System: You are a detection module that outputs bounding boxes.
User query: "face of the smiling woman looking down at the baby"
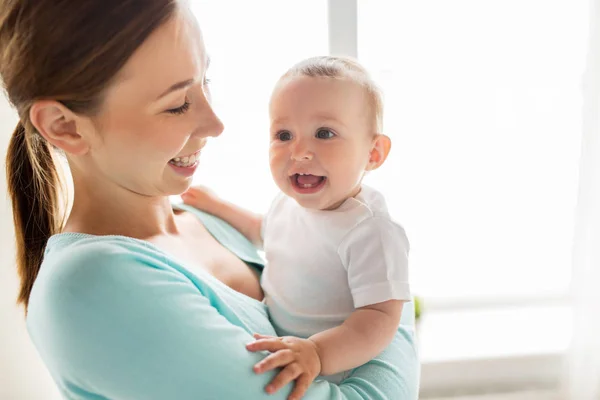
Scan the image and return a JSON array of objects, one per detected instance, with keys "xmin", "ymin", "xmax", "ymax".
[{"xmin": 76, "ymin": 10, "xmax": 223, "ymax": 196}]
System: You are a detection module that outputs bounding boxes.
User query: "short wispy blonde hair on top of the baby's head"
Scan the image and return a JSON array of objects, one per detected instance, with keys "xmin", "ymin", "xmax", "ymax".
[{"xmin": 279, "ymin": 56, "xmax": 383, "ymax": 133}]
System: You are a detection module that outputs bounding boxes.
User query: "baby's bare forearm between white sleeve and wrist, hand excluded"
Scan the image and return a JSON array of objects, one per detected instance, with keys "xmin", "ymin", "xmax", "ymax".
[{"xmin": 309, "ymin": 300, "xmax": 404, "ymax": 375}]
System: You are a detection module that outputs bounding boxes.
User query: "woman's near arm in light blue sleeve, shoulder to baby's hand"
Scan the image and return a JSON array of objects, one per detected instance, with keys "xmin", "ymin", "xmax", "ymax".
[{"xmin": 28, "ymin": 243, "xmax": 289, "ymax": 400}]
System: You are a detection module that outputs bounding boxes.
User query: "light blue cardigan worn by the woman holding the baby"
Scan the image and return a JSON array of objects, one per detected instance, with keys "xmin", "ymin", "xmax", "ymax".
[{"xmin": 27, "ymin": 206, "xmax": 419, "ymax": 400}]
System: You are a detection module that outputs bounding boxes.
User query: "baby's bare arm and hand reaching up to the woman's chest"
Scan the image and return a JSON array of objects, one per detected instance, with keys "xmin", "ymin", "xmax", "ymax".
[{"xmin": 181, "ymin": 186, "xmax": 263, "ymax": 247}]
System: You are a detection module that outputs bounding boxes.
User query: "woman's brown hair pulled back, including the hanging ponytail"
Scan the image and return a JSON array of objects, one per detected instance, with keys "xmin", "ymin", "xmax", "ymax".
[{"xmin": 0, "ymin": 0, "xmax": 177, "ymax": 309}]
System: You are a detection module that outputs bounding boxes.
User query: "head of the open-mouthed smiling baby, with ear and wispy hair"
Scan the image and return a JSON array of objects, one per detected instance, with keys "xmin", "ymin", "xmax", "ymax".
[{"xmin": 270, "ymin": 56, "xmax": 391, "ymax": 210}]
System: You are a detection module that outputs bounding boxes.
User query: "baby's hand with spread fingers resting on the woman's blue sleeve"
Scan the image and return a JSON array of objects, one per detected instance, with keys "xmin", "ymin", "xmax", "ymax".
[{"xmin": 246, "ymin": 334, "xmax": 321, "ymax": 400}]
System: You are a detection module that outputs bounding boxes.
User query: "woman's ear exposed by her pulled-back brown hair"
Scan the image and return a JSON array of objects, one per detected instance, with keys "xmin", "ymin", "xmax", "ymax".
[{"xmin": 29, "ymin": 100, "xmax": 89, "ymax": 155}]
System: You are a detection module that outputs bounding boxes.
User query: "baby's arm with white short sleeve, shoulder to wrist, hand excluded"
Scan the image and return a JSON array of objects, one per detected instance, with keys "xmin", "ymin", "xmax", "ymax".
[{"xmin": 310, "ymin": 217, "xmax": 410, "ymax": 375}]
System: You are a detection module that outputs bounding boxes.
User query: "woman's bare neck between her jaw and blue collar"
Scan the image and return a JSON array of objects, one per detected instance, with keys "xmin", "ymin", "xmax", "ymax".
[{"xmin": 64, "ymin": 173, "xmax": 178, "ymax": 239}]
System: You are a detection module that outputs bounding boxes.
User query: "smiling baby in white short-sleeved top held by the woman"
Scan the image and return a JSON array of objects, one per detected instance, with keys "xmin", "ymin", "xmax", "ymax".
[{"xmin": 182, "ymin": 57, "xmax": 411, "ymax": 399}]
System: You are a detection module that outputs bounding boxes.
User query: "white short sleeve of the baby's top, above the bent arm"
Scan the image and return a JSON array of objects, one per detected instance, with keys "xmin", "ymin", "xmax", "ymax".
[{"xmin": 338, "ymin": 217, "xmax": 411, "ymax": 308}]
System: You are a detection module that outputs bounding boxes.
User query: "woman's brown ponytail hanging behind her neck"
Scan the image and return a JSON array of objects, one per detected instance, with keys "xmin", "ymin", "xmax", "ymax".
[{"xmin": 6, "ymin": 122, "xmax": 62, "ymax": 310}]
